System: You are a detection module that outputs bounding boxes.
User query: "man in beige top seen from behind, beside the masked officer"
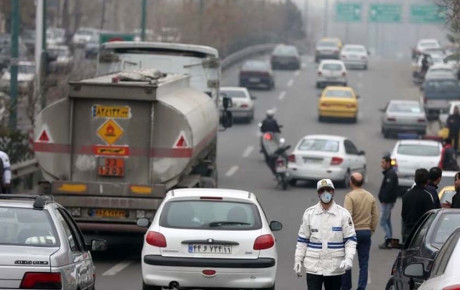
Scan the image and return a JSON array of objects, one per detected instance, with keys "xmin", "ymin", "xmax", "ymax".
[{"xmin": 342, "ymin": 173, "xmax": 379, "ymax": 290}]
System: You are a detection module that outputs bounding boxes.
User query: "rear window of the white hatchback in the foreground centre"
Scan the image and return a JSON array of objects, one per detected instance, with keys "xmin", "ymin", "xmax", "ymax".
[{"xmin": 160, "ymin": 199, "xmax": 262, "ymax": 230}]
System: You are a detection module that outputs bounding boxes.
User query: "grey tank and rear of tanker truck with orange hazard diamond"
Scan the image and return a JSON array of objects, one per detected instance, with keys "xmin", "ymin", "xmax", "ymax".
[{"xmin": 34, "ymin": 70, "xmax": 230, "ymax": 232}]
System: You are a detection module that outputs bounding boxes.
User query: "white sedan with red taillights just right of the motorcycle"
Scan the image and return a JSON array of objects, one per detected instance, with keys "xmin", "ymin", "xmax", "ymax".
[{"xmin": 288, "ymin": 135, "xmax": 366, "ymax": 186}]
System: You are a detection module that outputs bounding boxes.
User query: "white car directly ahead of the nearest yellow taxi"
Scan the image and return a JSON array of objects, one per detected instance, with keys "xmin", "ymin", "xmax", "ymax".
[{"xmin": 316, "ymin": 60, "xmax": 348, "ymax": 88}]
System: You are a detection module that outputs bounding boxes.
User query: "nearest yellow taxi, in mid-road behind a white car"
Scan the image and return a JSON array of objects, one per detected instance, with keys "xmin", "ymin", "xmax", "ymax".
[{"xmin": 318, "ymin": 86, "xmax": 359, "ymax": 123}]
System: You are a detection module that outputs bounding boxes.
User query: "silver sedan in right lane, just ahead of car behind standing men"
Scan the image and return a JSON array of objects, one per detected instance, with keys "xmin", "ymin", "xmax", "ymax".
[{"xmin": 381, "ymin": 100, "xmax": 427, "ymax": 138}]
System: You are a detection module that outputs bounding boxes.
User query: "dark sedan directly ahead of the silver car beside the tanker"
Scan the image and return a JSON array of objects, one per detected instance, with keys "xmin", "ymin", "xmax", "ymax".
[{"xmin": 240, "ymin": 60, "xmax": 275, "ymax": 90}]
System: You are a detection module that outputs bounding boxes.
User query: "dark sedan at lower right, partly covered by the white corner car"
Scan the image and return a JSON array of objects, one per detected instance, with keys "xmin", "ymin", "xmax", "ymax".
[{"xmin": 386, "ymin": 209, "xmax": 460, "ymax": 290}]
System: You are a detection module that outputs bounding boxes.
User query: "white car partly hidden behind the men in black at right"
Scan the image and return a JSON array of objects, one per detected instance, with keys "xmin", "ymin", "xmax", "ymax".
[{"xmin": 391, "ymin": 140, "xmax": 442, "ymax": 187}]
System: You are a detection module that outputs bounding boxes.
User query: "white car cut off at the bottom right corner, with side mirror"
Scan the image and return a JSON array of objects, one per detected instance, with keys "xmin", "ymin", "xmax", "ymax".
[{"xmin": 404, "ymin": 228, "xmax": 460, "ymax": 290}]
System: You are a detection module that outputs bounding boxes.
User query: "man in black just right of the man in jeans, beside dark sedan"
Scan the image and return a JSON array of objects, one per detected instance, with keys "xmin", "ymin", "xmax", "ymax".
[{"xmin": 401, "ymin": 168, "xmax": 434, "ymax": 243}]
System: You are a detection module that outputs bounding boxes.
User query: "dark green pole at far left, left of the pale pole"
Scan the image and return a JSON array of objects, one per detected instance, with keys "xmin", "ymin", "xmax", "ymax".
[{"xmin": 9, "ymin": 0, "xmax": 19, "ymax": 130}]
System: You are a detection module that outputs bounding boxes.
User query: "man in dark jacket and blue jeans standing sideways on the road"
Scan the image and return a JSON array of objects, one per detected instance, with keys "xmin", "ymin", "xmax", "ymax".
[{"xmin": 379, "ymin": 153, "xmax": 398, "ymax": 249}]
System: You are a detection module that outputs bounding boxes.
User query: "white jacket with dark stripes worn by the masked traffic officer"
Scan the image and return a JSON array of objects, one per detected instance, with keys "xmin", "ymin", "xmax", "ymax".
[{"xmin": 295, "ymin": 201, "xmax": 356, "ymax": 276}]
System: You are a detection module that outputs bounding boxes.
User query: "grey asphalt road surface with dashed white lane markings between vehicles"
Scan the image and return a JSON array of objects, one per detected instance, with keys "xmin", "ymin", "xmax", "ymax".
[{"xmin": 95, "ymin": 56, "xmax": 419, "ymax": 290}]
